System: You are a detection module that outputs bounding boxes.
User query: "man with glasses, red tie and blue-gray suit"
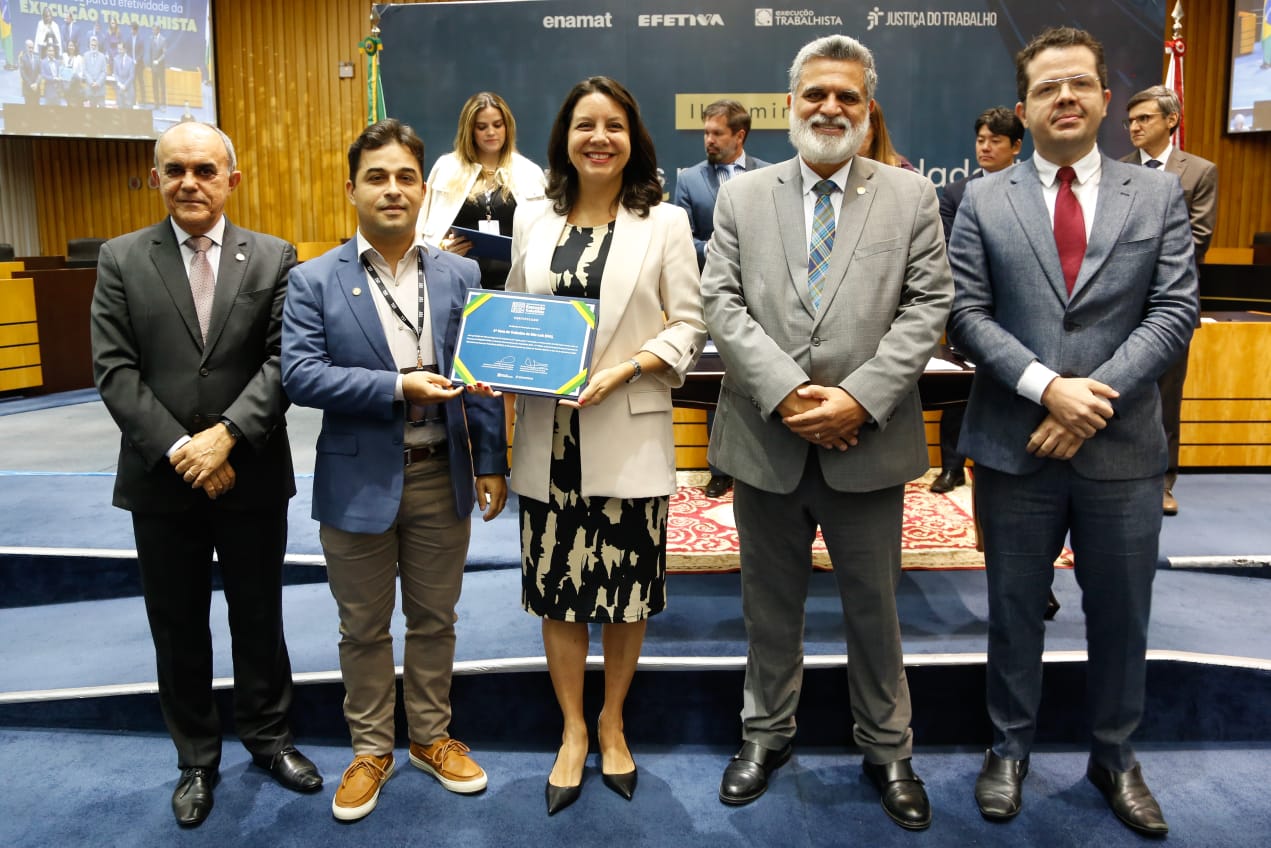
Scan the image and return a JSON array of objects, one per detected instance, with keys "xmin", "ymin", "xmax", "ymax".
[{"xmin": 949, "ymin": 27, "xmax": 1197, "ymax": 835}]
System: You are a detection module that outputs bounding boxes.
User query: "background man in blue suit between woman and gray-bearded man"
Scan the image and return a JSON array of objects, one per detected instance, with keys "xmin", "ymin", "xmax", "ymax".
[{"xmin": 671, "ymin": 100, "xmax": 768, "ymax": 497}]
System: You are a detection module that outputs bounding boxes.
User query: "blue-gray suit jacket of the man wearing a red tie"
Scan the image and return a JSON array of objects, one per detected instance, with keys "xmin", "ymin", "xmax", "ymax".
[{"xmin": 949, "ymin": 156, "xmax": 1199, "ymax": 479}]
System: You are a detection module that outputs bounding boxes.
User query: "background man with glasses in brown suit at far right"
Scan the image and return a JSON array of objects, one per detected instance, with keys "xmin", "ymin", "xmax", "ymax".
[{"xmin": 1121, "ymin": 85, "xmax": 1218, "ymax": 515}]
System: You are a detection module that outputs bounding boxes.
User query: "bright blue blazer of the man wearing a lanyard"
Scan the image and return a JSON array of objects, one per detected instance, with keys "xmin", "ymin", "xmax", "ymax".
[{"xmin": 282, "ymin": 239, "xmax": 507, "ymax": 533}]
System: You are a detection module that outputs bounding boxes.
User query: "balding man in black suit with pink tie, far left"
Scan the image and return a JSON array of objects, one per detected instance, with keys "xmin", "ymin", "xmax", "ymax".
[{"xmin": 92, "ymin": 123, "xmax": 322, "ymax": 825}]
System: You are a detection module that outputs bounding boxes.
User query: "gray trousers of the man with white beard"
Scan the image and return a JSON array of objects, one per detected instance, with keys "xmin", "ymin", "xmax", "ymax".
[{"xmin": 733, "ymin": 446, "xmax": 913, "ymax": 763}]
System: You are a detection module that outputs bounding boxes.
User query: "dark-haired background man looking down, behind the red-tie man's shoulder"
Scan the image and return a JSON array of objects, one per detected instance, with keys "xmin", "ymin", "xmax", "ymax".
[{"xmin": 932, "ymin": 106, "xmax": 1024, "ymax": 495}]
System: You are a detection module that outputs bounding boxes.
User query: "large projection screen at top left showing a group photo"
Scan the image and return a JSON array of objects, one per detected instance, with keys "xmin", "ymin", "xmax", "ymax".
[{"xmin": 0, "ymin": 0, "xmax": 216, "ymax": 139}]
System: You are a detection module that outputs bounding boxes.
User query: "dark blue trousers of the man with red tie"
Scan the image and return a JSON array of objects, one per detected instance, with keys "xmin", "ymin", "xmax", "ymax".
[{"xmin": 975, "ymin": 460, "xmax": 1160, "ymax": 772}]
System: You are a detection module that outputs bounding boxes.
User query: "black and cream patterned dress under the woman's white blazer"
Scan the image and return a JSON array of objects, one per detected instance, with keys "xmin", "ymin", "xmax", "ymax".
[{"xmin": 521, "ymin": 224, "xmax": 671, "ymax": 624}]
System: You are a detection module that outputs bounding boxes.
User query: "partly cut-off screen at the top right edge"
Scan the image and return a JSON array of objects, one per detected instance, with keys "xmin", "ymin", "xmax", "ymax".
[{"xmin": 1227, "ymin": 0, "xmax": 1271, "ymax": 132}]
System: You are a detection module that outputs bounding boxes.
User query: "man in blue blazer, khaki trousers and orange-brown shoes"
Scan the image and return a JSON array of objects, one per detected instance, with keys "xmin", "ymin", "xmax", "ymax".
[{"xmin": 282, "ymin": 120, "xmax": 507, "ymax": 821}]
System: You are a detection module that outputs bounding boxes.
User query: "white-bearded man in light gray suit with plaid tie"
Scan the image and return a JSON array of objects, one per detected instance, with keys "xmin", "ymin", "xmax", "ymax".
[{"xmin": 702, "ymin": 36, "xmax": 953, "ymax": 829}]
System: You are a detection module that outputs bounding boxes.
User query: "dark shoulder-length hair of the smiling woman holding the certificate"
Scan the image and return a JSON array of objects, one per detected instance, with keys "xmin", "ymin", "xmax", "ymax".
[{"xmin": 545, "ymin": 76, "xmax": 662, "ymax": 217}]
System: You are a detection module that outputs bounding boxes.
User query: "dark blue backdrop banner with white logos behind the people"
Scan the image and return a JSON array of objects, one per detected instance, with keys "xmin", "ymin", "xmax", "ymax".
[{"xmin": 376, "ymin": 0, "xmax": 1166, "ymax": 191}]
